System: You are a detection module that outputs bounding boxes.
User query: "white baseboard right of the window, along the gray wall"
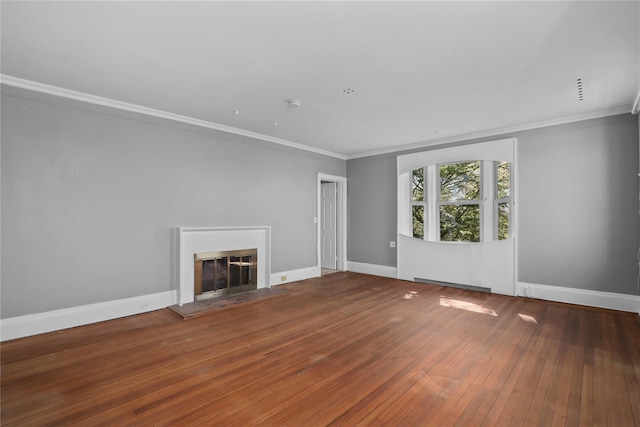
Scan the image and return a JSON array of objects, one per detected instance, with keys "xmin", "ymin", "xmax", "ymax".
[{"xmin": 516, "ymin": 282, "xmax": 640, "ymax": 314}]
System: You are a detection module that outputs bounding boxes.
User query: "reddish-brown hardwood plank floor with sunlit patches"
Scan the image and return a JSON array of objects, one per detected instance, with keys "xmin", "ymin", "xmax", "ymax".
[{"xmin": 1, "ymin": 272, "xmax": 640, "ymax": 426}]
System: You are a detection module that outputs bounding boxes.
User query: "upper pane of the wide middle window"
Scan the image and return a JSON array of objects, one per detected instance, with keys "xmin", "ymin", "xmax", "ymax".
[{"xmin": 439, "ymin": 161, "xmax": 480, "ymax": 201}]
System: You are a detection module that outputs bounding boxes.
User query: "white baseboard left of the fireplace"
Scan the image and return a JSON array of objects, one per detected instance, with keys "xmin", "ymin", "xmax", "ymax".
[{"xmin": 0, "ymin": 291, "xmax": 177, "ymax": 341}]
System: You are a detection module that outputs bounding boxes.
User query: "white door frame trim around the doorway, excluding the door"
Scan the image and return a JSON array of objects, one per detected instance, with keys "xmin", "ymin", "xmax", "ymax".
[{"xmin": 315, "ymin": 172, "xmax": 347, "ymax": 276}]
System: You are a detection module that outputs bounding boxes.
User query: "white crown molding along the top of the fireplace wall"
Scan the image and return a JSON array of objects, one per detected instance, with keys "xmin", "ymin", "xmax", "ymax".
[{"xmin": 0, "ymin": 74, "xmax": 347, "ymax": 160}]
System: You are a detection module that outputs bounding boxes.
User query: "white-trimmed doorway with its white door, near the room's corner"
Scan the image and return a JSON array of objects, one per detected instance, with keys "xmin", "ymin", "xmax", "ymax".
[{"xmin": 316, "ymin": 173, "xmax": 347, "ymax": 274}]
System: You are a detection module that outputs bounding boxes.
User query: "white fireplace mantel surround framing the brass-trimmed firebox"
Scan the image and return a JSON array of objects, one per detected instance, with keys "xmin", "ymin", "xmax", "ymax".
[{"xmin": 176, "ymin": 226, "xmax": 271, "ymax": 305}]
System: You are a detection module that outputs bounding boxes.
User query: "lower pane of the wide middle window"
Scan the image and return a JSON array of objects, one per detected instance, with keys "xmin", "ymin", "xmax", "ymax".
[{"xmin": 440, "ymin": 205, "xmax": 480, "ymax": 242}]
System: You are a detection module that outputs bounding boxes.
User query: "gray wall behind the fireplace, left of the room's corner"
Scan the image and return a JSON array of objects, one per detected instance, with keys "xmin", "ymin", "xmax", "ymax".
[{"xmin": 1, "ymin": 88, "xmax": 346, "ymax": 318}]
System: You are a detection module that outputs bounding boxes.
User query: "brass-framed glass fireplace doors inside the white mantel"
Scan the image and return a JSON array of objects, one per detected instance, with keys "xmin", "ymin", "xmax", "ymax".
[{"xmin": 193, "ymin": 248, "xmax": 258, "ymax": 300}]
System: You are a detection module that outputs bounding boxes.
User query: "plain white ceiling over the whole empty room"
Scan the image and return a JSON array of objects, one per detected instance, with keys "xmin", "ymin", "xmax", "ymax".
[{"xmin": 1, "ymin": 1, "xmax": 640, "ymax": 158}]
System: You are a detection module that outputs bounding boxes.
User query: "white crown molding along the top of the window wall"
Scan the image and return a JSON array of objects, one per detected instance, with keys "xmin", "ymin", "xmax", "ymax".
[{"xmin": 347, "ymin": 106, "xmax": 638, "ymax": 160}]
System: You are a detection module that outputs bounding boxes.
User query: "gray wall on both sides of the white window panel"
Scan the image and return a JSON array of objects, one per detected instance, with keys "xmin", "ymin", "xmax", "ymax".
[{"xmin": 347, "ymin": 114, "xmax": 639, "ymax": 294}]
